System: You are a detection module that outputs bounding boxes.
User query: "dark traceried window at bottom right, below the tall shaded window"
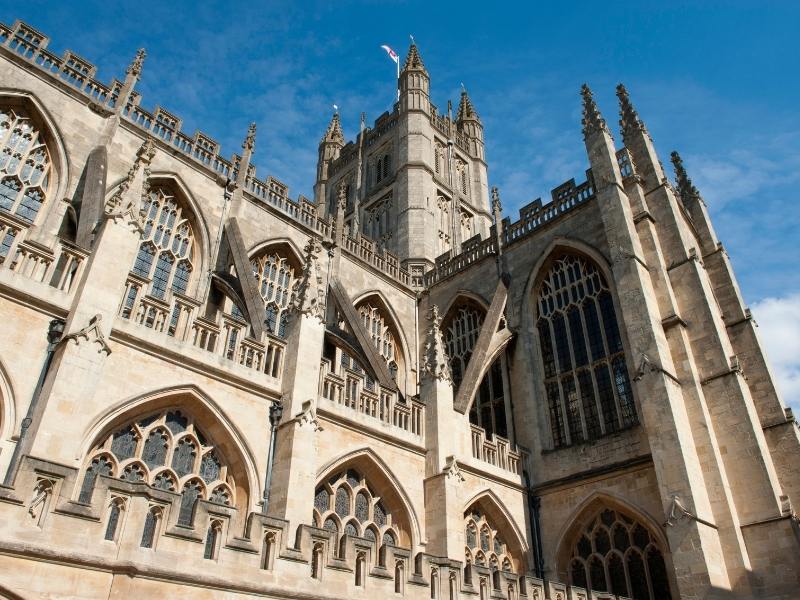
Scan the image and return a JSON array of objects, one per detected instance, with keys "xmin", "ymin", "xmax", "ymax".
[{"xmin": 569, "ymin": 509, "xmax": 672, "ymax": 600}]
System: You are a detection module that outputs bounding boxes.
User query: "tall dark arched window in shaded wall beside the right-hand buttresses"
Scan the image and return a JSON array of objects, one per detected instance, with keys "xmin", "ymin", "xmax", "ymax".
[{"xmin": 536, "ymin": 254, "xmax": 637, "ymax": 447}]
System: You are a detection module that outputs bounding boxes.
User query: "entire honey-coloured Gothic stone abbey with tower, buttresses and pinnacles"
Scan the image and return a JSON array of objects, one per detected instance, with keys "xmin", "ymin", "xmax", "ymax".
[{"xmin": 0, "ymin": 22, "xmax": 800, "ymax": 600}]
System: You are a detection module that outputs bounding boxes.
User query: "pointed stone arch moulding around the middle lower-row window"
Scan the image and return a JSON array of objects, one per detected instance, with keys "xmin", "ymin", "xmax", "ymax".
[{"xmin": 317, "ymin": 448, "xmax": 422, "ymax": 548}]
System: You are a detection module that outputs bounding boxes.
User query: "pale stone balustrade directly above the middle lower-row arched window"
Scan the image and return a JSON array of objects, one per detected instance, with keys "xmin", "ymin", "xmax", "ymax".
[{"xmin": 320, "ymin": 360, "xmax": 425, "ymax": 438}]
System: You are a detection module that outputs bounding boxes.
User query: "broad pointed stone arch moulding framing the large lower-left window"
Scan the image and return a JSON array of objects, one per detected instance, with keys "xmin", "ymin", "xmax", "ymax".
[{"xmin": 75, "ymin": 385, "xmax": 261, "ymax": 512}]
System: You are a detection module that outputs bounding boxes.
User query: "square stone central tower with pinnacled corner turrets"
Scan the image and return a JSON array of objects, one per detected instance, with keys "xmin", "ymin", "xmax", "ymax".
[{"xmin": 315, "ymin": 44, "xmax": 491, "ymax": 276}]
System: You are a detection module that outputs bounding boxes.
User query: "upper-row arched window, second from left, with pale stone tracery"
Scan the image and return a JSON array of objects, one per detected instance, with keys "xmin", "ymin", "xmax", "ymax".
[{"xmin": 132, "ymin": 186, "xmax": 196, "ymax": 300}]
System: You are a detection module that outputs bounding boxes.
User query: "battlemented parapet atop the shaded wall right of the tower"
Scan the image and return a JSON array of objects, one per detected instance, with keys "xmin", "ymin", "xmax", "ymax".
[{"xmin": 423, "ymin": 171, "xmax": 595, "ymax": 286}]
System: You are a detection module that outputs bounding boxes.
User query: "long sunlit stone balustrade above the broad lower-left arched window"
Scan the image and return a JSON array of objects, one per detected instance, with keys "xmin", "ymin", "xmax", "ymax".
[{"xmin": 119, "ymin": 273, "xmax": 286, "ymax": 380}]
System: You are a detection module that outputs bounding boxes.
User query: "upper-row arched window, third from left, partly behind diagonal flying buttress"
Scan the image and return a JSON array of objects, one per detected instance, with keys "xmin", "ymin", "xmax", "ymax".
[{"xmin": 251, "ymin": 251, "xmax": 295, "ymax": 337}]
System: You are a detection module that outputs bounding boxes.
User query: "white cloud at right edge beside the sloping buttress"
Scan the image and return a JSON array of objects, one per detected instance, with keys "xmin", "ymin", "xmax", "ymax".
[{"xmin": 752, "ymin": 293, "xmax": 800, "ymax": 416}]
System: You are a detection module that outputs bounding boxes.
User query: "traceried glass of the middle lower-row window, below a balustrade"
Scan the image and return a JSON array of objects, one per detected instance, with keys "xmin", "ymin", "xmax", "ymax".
[{"xmin": 313, "ymin": 469, "xmax": 400, "ymax": 546}]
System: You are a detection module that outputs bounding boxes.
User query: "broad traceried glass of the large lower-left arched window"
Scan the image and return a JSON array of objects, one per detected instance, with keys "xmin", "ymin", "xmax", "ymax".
[{"xmin": 79, "ymin": 409, "xmax": 236, "ymax": 524}]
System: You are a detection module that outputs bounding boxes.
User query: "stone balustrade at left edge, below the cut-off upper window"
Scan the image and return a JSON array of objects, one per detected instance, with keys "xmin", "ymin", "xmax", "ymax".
[{"xmin": 0, "ymin": 210, "xmax": 89, "ymax": 293}]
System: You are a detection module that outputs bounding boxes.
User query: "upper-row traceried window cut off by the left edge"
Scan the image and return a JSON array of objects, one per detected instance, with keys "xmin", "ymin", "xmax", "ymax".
[{"xmin": 0, "ymin": 107, "xmax": 52, "ymax": 223}]
